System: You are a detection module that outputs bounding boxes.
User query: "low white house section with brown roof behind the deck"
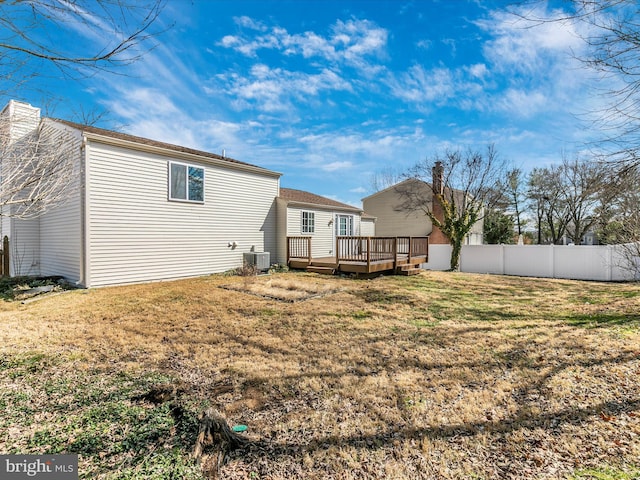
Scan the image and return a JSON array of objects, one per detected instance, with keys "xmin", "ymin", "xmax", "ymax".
[{"xmin": 276, "ymin": 188, "xmax": 375, "ymax": 263}]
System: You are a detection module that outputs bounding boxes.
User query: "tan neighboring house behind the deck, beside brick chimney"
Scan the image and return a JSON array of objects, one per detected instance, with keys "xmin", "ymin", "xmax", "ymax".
[{"xmin": 362, "ymin": 179, "xmax": 483, "ymax": 245}]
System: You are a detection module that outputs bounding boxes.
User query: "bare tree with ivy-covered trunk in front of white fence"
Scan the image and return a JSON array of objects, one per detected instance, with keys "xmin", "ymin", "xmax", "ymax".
[{"xmin": 396, "ymin": 145, "xmax": 506, "ymax": 270}]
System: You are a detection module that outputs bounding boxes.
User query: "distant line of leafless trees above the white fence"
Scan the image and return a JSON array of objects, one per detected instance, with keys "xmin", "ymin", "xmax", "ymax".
[{"xmin": 484, "ymin": 156, "xmax": 640, "ymax": 245}]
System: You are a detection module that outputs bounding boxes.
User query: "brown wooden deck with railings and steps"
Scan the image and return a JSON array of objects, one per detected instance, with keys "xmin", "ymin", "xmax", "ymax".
[{"xmin": 287, "ymin": 237, "xmax": 429, "ymax": 275}]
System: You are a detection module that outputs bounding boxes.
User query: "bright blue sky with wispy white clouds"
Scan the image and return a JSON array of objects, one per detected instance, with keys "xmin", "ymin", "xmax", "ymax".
[{"xmin": 0, "ymin": 0, "xmax": 603, "ymax": 206}]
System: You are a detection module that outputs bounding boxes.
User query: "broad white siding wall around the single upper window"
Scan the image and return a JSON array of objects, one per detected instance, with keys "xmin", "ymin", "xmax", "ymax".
[{"xmin": 86, "ymin": 142, "xmax": 278, "ymax": 286}]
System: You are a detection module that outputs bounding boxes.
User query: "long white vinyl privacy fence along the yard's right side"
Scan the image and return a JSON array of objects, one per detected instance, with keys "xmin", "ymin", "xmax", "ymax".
[{"xmin": 422, "ymin": 245, "xmax": 640, "ymax": 281}]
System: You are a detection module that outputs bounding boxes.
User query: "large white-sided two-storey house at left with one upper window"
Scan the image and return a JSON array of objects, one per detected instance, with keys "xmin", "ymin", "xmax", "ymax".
[{"xmin": 0, "ymin": 101, "xmax": 280, "ymax": 287}]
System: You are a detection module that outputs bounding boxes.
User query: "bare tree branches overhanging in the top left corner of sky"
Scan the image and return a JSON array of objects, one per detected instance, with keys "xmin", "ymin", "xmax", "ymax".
[{"xmin": 0, "ymin": 0, "xmax": 163, "ymax": 93}]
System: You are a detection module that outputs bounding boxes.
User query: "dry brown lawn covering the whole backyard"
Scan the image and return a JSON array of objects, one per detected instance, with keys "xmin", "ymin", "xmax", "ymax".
[{"xmin": 0, "ymin": 272, "xmax": 640, "ymax": 479}]
